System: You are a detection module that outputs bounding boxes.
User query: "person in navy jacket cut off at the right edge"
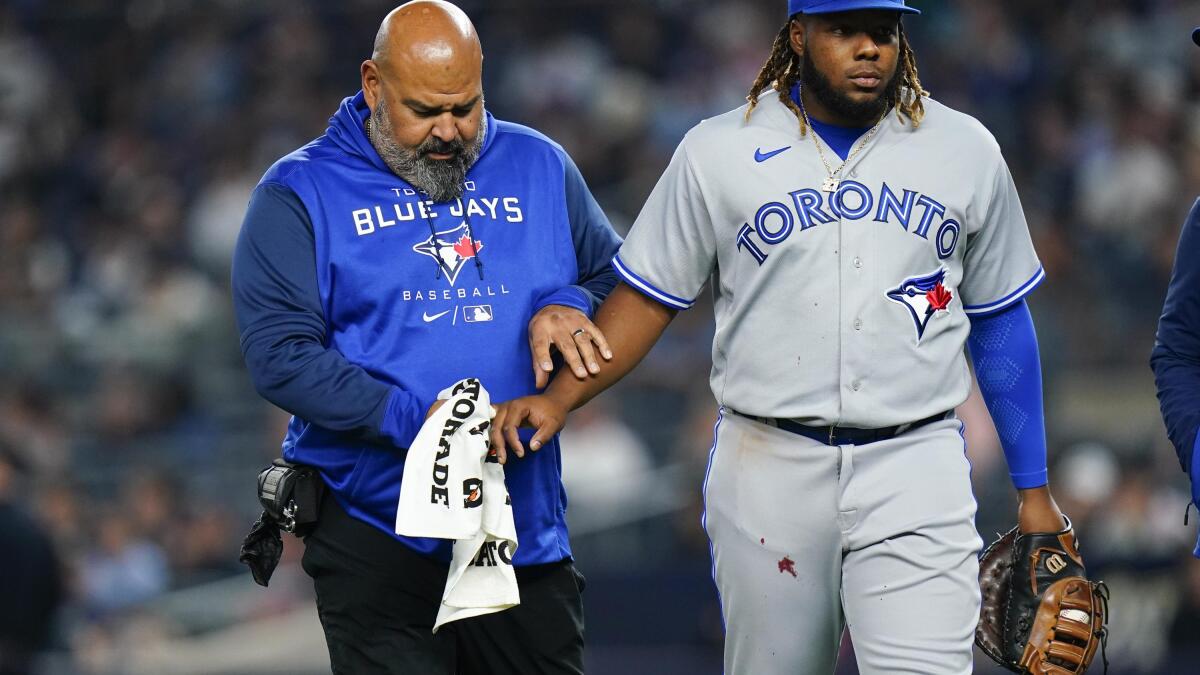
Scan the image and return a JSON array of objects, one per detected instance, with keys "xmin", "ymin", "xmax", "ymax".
[{"xmin": 1150, "ymin": 28, "xmax": 1200, "ymax": 557}]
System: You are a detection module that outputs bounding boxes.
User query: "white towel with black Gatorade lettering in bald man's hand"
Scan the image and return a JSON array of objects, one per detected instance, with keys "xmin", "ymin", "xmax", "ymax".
[{"xmin": 396, "ymin": 378, "xmax": 521, "ymax": 633}]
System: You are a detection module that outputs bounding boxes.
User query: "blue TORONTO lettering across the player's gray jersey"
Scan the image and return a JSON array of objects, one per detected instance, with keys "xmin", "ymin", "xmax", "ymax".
[{"xmin": 738, "ymin": 180, "xmax": 962, "ymax": 265}]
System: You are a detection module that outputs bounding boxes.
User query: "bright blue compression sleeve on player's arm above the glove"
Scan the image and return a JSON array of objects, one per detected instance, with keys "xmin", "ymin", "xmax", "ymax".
[{"xmin": 967, "ymin": 300, "xmax": 1048, "ymax": 490}]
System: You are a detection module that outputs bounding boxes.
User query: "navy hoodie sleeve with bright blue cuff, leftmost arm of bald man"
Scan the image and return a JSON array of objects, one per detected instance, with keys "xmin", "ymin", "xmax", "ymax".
[{"xmin": 233, "ymin": 184, "xmax": 427, "ymax": 448}]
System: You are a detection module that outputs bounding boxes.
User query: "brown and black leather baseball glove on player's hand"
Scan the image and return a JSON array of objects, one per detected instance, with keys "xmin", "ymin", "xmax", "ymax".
[{"xmin": 976, "ymin": 521, "xmax": 1109, "ymax": 675}]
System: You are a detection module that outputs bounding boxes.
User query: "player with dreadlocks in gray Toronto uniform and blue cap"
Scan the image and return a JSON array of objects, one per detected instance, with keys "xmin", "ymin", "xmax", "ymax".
[{"xmin": 492, "ymin": 0, "xmax": 1066, "ymax": 675}]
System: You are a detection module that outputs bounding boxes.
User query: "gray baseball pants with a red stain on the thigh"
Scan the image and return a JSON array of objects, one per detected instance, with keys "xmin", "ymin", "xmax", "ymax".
[{"xmin": 704, "ymin": 411, "xmax": 983, "ymax": 675}]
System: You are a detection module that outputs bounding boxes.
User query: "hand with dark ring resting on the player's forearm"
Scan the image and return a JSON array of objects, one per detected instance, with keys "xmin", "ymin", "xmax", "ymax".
[{"xmin": 529, "ymin": 305, "xmax": 612, "ymax": 389}]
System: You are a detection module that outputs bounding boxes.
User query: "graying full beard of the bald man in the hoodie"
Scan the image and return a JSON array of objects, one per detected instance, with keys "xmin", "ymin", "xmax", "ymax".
[{"xmin": 366, "ymin": 98, "xmax": 487, "ymax": 203}]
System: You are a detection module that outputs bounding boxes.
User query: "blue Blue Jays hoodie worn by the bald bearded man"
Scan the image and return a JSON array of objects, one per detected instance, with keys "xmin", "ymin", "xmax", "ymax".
[{"xmin": 233, "ymin": 91, "xmax": 620, "ymax": 566}]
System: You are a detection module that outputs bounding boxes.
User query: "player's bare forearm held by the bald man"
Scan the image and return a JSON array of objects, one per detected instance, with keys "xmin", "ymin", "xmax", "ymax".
[{"xmin": 546, "ymin": 283, "xmax": 676, "ymax": 410}]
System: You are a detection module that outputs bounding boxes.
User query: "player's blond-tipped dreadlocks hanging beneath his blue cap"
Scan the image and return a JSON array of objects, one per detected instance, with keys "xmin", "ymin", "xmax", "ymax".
[{"xmin": 746, "ymin": 19, "xmax": 929, "ymax": 136}]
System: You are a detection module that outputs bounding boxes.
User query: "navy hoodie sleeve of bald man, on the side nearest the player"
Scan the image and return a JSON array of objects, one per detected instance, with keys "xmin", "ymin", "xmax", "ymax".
[{"xmin": 533, "ymin": 153, "xmax": 620, "ymax": 318}]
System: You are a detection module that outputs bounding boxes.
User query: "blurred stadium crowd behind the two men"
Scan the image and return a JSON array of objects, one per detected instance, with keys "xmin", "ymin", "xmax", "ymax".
[{"xmin": 0, "ymin": 0, "xmax": 1200, "ymax": 675}]
